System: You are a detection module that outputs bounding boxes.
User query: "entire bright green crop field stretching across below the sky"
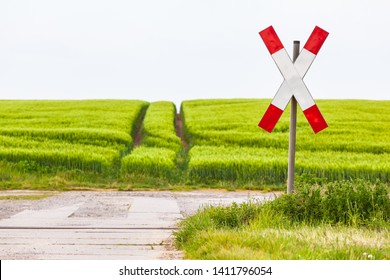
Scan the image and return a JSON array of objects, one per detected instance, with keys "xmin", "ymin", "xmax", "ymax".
[{"xmin": 0, "ymin": 99, "xmax": 390, "ymax": 189}]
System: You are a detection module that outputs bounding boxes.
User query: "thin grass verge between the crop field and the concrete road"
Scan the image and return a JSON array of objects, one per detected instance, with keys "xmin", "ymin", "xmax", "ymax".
[{"xmin": 0, "ymin": 161, "xmax": 284, "ymax": 191}]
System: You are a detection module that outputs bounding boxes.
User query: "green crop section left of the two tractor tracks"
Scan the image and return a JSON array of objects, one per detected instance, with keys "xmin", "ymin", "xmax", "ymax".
[{"xmin": 0, "ymin": 100, "xmax": 147, "ymax": 178}]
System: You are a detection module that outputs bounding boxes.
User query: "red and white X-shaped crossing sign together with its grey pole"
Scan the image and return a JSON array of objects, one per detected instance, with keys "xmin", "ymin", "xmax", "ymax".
[{"xmin": 258, "ymin": 25, "xmax": 329, "ymax": 190}]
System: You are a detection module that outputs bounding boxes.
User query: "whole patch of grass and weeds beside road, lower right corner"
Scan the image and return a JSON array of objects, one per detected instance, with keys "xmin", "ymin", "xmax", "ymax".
[{"xmin": 175, "ymin": 181, "xmax": 390, "ymax": 260}]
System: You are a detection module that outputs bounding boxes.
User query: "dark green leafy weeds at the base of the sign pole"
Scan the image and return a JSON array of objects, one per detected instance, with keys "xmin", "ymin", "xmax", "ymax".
[{"xmin": 264, "ymin": 180, "xmax": 390, "ymax": 227}]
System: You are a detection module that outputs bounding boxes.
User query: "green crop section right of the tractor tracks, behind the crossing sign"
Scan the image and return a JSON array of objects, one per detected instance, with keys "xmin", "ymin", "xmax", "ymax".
[{"xmin": 182, "ymin": 99, "xmax": 390, "ymax": 183}]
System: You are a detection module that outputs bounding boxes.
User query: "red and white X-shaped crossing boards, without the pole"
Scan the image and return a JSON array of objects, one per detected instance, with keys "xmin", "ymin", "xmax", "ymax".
[{"xmin": 259, "ymin": 26, "xmax": 329, "ymax": 133}]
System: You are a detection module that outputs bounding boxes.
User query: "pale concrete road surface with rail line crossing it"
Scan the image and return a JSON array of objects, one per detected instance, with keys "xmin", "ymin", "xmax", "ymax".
[{"xmin": 0, "ymin": 191, "xmax": 275, "ymax": 260}]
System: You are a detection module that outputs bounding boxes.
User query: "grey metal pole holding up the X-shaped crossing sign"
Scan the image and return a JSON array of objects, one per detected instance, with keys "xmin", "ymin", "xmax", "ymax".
[{"xmin": 287, "ymin": 41, "xmax": 300, "ymax": 193}]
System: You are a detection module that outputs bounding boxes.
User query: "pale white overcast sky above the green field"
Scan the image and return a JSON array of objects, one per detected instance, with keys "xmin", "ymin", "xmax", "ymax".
[{"xmin": 0, "ymin": 0, "xmax": 390, "ymax": 104}]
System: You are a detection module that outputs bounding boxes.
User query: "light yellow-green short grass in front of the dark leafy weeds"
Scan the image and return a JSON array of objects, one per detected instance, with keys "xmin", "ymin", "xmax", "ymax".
[{"xmin": 182, "ymin": 224, "xmax": 390, "ymax": 260}]
